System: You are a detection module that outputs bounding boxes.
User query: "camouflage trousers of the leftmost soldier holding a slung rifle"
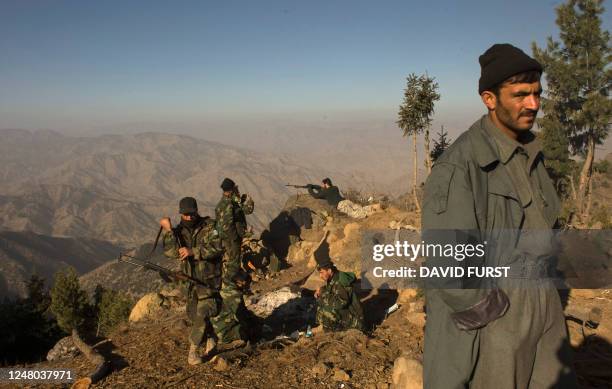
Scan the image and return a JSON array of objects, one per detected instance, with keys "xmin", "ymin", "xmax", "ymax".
[{"xmin": 187, "ymin": 292, "xmax": 221, "ymax": 346}]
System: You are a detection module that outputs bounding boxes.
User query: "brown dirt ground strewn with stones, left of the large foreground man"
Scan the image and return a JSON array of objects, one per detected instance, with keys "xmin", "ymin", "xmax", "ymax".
[{"xmin": 17, "ymin": 266, "xmax": 423, "ymax": 389}]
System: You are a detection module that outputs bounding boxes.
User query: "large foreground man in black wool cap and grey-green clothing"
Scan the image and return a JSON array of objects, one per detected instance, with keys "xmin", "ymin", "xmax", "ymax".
[{"xmin": 422, "ymin": 44, "xmax": 576, "ymax": 389}]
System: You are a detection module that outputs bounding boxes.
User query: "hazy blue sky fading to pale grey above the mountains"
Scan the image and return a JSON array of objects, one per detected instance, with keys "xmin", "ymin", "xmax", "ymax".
[{"xmin": 0, "ymin": 0, "xmax": 609, "ymax": 133}]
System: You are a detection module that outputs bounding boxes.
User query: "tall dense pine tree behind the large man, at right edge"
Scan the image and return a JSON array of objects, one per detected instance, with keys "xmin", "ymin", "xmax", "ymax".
[{"xmin": 532, "ymin": 0, "xmax": 612, "ymax": 221}]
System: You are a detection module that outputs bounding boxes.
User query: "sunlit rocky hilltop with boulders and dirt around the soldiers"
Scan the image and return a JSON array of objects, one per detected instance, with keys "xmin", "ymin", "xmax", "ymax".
[{"xmin": 21, "ymin": 202, "xmax": 612, "ymax": 389}]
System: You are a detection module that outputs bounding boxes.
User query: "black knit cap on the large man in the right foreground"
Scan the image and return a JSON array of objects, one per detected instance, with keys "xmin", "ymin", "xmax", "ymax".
[{"xmin": 478, "ymin": 43, "xmax": 542, "ymax": 94}]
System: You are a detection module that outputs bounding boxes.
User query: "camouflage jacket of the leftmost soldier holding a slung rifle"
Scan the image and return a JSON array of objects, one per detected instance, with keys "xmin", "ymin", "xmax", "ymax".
[{"xmin": 163, "ymin": 217, "xmax": 223, "ymax": 297}]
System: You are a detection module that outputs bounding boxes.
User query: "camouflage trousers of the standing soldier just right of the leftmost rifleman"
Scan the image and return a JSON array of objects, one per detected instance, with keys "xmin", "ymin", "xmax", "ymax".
[{"xmin": 211, "ymin": 258, "xmax": 244, "ymax": 343}]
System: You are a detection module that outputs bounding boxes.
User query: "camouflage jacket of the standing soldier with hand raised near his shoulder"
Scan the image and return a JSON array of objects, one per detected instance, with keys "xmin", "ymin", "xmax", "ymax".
[{"xmin": 215, "ymin": 195, "xmax": 255, "ymax": 257}]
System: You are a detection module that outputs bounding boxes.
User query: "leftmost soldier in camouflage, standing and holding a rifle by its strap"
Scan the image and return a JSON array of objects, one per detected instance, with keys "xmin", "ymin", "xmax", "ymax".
[{"xmin": 160, "ymin": 197, "xmax": 223, "ymax": 365}]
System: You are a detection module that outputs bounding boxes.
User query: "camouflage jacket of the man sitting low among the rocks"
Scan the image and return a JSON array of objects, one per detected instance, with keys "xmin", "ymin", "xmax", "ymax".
[{"xmin": 317, "ymin": 271, "xmax": 365, "ymax": 331}]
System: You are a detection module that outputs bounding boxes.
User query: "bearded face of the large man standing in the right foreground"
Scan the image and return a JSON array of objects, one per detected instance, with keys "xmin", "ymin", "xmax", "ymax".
[{"xmin": 485, "ymin": 81, "xmax": 542, "ymax": 133}]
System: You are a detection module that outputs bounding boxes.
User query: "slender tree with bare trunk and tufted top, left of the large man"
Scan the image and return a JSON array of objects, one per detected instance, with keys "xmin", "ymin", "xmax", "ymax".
[{"xmin": 396, "ymin": 73, "xmax": 440, "ymax": 212}]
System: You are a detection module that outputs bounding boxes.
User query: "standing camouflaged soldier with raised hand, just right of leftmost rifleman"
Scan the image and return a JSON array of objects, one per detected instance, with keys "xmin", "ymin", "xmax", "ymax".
[{"xmin": 212, "ymin": 178, "xmax": 254, "ymax": 343}]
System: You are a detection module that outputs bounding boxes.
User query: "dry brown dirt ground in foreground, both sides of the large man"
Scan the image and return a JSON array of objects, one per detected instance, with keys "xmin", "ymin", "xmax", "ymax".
[{"xmin": 14, "ymin": 273, "xmax": 612, "ymax": 389}]
